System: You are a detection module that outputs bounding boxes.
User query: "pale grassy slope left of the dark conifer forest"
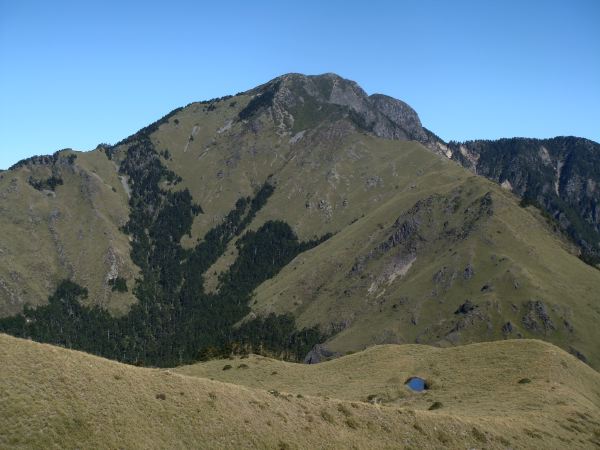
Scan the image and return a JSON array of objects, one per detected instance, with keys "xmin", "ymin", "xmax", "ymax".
[{"xmin": 0, "ymin": 151, "xmax": 137, "ymax": 315}]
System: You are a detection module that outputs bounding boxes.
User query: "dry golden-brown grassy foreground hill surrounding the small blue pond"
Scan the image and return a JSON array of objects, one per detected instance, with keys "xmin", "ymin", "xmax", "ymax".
[{"xmin": 0, "ymin": 335, "xmax": 600, "ymax": 449}]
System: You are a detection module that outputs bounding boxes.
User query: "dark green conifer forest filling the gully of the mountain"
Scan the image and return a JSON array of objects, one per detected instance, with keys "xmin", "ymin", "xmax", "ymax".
[{"xmin": 0, "ymin": 126, "xmax": 329, "ymax": 366}]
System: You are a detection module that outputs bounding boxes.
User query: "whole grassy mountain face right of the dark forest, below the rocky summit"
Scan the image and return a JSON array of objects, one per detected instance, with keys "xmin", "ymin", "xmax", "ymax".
[{"xmin": 126, "ymin": 95, "xmax": 600, "ymax": 367}]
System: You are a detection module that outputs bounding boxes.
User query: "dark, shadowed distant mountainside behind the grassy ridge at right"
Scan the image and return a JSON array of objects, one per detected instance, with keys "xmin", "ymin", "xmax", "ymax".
[{"xmin": 448, "ymin": 137, "xmax": 600, "ymax": 265}]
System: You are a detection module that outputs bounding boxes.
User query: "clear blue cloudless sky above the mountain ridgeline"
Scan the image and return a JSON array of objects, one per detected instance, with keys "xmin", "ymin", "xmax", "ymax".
[{"xmin": 0, "ymin": 0, "xmax": 600, "ymax": 168}]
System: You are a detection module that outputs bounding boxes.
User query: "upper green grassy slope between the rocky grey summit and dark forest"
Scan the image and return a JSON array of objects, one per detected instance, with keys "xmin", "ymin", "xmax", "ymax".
[{"xmin": 153, "ymin": 96, "xmax": 446, "ymax": 243}]
